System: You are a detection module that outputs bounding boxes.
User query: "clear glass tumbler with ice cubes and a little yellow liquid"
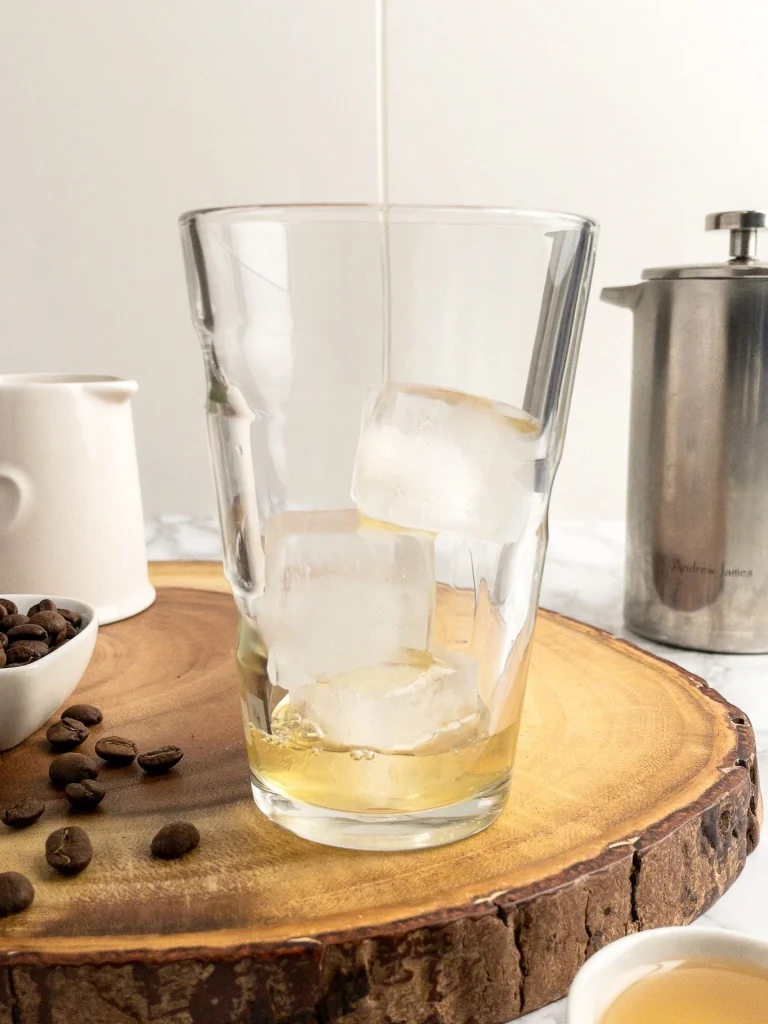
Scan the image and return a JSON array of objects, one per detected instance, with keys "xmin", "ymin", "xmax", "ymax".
[{"xmin": 181, "ymin": 206, "xmax": 596, "ymax": 850}]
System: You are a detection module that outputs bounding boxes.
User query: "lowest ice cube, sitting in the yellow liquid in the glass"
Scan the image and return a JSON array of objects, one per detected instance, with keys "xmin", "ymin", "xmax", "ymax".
[{"xmin": 291, "ymin": 650, "xmax": 487, "ymax": 754}]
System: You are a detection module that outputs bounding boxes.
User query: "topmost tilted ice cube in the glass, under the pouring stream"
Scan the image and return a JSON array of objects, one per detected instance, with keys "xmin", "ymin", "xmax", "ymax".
[{"xmin": 352, "ymin": 384, "xmax": 545, "ymax": 542}]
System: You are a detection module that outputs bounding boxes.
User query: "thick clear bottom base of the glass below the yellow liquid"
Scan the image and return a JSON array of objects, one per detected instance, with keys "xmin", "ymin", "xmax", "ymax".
[{"xmin": 251, "ymin": 775, "xmax": 509, "ymax": 851}]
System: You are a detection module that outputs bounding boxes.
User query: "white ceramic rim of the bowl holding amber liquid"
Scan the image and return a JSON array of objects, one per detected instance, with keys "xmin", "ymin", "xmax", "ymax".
[{"xmin": 567, "ymin": 928, "xmax": 768, "ymax": 1024}]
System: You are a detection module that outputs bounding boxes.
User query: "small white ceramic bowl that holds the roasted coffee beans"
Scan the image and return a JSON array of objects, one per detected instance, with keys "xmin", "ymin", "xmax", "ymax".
[{"xmin": 0, "ymin": 594, "xmax": 98, "ymax": 751}]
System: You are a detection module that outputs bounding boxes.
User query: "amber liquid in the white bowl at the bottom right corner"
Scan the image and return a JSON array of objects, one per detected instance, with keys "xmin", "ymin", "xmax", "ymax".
[{"xmin": 601, "ymin": 957, "xmax": 768, "ymax": 1024}]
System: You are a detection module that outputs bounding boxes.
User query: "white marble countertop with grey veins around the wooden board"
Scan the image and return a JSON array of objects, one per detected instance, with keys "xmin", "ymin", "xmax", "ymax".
[{"xmin": 147, "ymin": 516, "xmax": 768, "ymax": 1024}]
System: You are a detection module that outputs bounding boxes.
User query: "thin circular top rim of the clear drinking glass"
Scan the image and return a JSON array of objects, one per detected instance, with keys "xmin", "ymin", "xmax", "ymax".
[{"xmin": 178, "ymin": 203, "xmax": 598, "ymax": 231}]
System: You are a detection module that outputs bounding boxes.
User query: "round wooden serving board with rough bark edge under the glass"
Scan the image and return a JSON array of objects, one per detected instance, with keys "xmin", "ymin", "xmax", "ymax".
[{"xmin": 0, "ymin": 563, "xmax": 761, "ymax": 1024}]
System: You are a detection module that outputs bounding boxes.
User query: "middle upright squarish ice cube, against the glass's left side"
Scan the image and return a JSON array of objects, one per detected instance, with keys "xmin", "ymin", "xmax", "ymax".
[{"xmin": 256, "ymin": 510, "xmax": 435, "ymax": 690}]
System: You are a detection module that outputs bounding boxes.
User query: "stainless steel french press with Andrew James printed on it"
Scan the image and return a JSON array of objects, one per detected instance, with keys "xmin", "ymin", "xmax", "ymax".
[{"xmin": 601, "ymin": 210, "xmax": 768, "ymax": 653}]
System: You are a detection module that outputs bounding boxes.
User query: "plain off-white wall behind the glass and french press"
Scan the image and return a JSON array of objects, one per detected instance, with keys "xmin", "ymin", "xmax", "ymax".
[{"xmin": 0, "ymin": 0, "xmax": 768, "ymax": 520}]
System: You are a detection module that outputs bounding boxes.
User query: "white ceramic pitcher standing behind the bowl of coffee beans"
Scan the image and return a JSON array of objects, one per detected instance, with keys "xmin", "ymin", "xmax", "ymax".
[{"xmin": 0, "ymin": 374, "xmax": 155, "ymax": 624}]
